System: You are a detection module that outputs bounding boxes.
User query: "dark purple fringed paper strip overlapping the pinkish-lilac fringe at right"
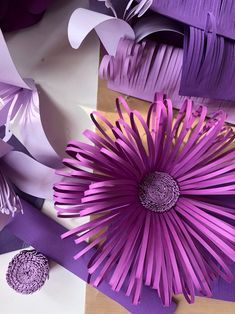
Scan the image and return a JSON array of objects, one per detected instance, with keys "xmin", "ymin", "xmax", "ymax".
[{"xmin": 180, "ymin": 26, "xmax": 235, "ymax": 102}]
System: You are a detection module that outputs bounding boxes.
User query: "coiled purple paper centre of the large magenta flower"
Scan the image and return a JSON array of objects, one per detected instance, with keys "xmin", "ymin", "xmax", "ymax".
[{"xmin": 139, "ymin": 171, "xmax": 180, "ymax": 213}]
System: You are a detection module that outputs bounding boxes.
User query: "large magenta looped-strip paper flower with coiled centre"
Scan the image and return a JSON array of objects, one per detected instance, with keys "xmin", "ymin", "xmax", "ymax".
[{"xmin": 55, "ymin": 97, "xmax": 235, "ymax": 306}]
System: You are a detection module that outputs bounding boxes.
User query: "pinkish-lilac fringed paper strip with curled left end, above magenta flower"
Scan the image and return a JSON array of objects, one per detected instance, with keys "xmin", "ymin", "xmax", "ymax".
[{"xmin": 99, "ymin": 39, "xmax": 235, "ymax": 122}]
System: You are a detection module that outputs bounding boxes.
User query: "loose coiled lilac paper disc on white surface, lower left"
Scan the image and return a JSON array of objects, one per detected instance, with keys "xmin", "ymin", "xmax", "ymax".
[{"xmin": 6, "ymin": 250, "xmax": 49, "ymax": 294}]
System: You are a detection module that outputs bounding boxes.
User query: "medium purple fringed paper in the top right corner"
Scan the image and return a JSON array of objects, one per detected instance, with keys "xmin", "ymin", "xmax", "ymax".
[{"xmin": 138, "ymin": 0, "xmax": 235, "ymax": 39}]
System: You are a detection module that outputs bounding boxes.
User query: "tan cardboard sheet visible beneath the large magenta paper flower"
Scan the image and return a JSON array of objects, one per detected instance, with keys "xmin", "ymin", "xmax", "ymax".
[{"xmin": 85, "ymin": 80, "xmax": 235, "ymax": 314}]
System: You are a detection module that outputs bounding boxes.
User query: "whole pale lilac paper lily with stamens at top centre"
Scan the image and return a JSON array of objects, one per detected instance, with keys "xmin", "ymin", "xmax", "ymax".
[{"xmin": 68, "ymin": 4, "xmax": 183, "ymax": 55}]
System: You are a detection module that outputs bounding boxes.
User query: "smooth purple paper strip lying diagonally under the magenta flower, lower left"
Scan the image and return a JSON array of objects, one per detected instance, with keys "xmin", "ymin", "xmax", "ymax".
[{"xmin": 7, "ymin": 200, "xmax": 175, "ymax": 314}]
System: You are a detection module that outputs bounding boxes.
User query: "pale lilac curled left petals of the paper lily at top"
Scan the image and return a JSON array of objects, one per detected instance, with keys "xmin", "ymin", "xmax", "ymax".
[{"xmin": 68, "ymin": 8, "xmax": 135, "ymax": 55}]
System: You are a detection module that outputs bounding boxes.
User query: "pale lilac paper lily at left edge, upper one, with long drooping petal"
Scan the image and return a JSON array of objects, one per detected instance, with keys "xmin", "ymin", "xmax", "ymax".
[{"xmin": 0, "ymin": 32, "xmax": 61, "ymax": 168}]
